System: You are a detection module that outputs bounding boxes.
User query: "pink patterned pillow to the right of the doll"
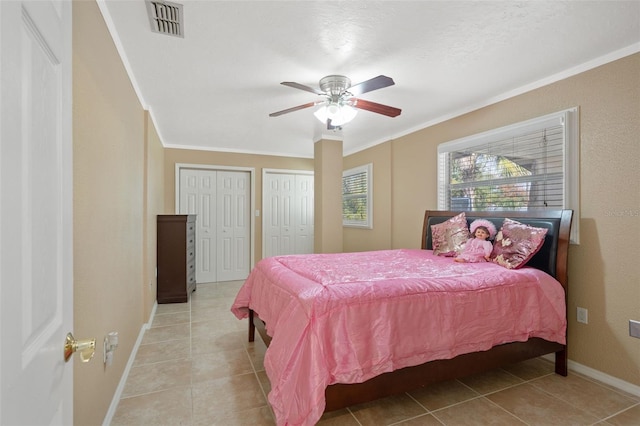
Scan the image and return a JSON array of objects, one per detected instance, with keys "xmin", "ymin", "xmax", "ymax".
[{"xmin": 491, "ymin": 218, "xmax": 547, "ymax": 269}]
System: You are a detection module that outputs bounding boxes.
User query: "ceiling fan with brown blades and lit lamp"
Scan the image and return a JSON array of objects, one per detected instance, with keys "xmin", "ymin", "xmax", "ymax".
[{"xmin": 269, "ymin": 75, "xmax": 402, "ymax": 130}]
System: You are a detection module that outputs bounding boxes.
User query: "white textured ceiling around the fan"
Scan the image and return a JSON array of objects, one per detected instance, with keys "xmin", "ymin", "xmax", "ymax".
[{"xmin": 98, "ymin": 0, "xmax": 640, "ymax": 157}]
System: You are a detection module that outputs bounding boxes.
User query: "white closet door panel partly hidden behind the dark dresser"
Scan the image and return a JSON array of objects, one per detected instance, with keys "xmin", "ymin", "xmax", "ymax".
[{"xmin": 180, "ymin": 169, "xmax": 216, "ymax": 283}]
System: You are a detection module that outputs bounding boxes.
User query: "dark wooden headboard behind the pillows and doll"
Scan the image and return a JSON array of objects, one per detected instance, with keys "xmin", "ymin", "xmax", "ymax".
[{"xmin": 422, "ymin": 210, "xmax": 573, "ymax": 289}]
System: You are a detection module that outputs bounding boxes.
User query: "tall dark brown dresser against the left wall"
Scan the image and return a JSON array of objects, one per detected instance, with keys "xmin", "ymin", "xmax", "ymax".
[{"xmin": 157, "ymin": 214, "xmax": 196, "ymax": 303}]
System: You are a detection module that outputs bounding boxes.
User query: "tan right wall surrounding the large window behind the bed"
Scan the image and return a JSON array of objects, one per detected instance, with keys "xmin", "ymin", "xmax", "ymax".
[{"xmin": 345, "ymin": 54, "xmax": 640, "ymax": 385}]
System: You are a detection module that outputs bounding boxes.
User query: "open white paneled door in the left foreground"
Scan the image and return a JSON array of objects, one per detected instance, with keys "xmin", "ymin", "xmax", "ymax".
[{"xmin": 0, "ymin": 1, "xmax": 73, "ymax": 425}]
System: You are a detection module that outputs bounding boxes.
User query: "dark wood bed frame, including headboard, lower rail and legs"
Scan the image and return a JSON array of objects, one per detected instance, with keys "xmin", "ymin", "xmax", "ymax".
[{"xmin": 249, "ymin": 210, "xmax": 573, "ymax": 411}]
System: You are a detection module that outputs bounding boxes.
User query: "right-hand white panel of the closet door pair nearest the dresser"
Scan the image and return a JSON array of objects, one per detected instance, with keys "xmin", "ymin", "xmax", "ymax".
[{"xmin": 216, "ymin": 171, "xmax": 250, "ymax": 281}]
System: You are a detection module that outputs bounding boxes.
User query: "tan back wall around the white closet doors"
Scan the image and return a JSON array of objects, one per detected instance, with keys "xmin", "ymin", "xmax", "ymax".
[{"xmin": 164, "ymin": 150, "xmax": 313, "ymax": 262}]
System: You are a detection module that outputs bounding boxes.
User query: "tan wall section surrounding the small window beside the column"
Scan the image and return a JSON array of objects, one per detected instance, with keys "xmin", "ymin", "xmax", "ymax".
[{"xmin": 343, "ymin": 143, "xmax": 393, "ymax": 252}]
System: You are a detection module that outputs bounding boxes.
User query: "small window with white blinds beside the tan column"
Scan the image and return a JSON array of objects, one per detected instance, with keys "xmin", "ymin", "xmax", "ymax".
[{"xmin": 342, "ymin": 164, "xmax": 373, "ymax": 229}]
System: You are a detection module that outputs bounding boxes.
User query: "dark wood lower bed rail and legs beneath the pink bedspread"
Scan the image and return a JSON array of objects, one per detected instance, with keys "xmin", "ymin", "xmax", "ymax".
[{"xmin": 249, "ymin": 310, "xmax": 567, "ymax": 411}]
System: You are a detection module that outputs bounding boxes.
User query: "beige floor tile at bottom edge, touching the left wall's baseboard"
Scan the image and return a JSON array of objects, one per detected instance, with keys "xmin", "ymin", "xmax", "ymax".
[{"xmin": 111, "ymin": 386, "xmax": 192, "ymax": 426}]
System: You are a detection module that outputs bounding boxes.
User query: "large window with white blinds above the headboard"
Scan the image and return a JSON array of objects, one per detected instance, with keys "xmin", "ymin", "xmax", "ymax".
[{"xmin": 438, "ymin": 108, "xmax": 579, "ymax": 243}]
